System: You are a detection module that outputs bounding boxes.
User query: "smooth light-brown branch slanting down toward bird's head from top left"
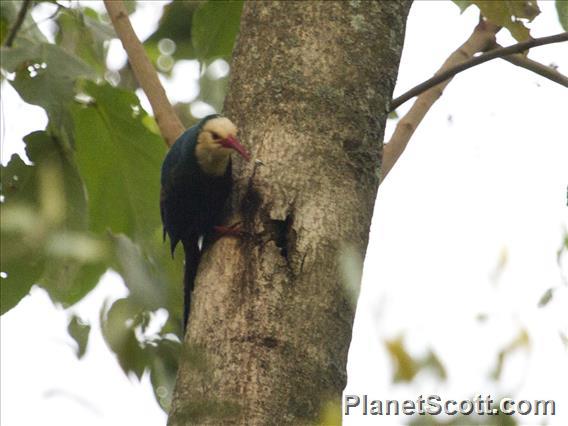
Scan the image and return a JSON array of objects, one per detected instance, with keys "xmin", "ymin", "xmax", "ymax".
[{"xmin": 104, "ymin": 0, "xmax": 185, "ymax": 146}]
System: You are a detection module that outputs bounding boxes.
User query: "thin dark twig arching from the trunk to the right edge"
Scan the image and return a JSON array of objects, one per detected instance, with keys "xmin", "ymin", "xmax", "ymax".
[{"xmin": 389, "ymin": 32, "xmax": 568, "ymax": 112}]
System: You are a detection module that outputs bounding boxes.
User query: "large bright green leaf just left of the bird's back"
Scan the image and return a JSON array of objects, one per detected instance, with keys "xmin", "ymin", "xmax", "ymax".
[{"xmin": 72, "ymin": 82, "xmax": 165, "ymax": 240}]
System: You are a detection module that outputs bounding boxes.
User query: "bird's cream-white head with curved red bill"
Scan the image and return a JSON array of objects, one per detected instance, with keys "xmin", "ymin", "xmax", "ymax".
[{"xmin": 195, "ymin": 117, "xmax": 250, "ymax": 176}]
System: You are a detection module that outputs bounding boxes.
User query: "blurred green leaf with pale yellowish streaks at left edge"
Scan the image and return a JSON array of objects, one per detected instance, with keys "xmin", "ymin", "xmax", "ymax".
[{"xmin": 0, "ymin": 132, "xmax": 106, "ymax": 313}]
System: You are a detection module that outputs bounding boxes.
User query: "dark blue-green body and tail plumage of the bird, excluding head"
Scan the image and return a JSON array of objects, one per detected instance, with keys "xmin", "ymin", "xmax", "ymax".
[{"xmin": 160, "ymin": 115, "xmax": 232, "ymax": 326}]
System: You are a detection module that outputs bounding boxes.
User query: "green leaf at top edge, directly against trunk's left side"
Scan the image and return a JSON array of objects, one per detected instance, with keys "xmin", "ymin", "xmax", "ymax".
[{"xmin": 192, "ymin": 1, "xmax": 243, "ymax": 62}]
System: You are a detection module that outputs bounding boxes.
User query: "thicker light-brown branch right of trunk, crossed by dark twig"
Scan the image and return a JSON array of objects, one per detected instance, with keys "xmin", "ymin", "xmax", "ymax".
[{"xmin": 380, "ymin": 21, "xmax": 500, "ymax": 183}]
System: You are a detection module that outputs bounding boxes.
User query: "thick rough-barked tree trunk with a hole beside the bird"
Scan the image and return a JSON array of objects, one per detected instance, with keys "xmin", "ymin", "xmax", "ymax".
[{"xmin": 169, "ymin": 0, "xmax": 410, "ymax": 426}]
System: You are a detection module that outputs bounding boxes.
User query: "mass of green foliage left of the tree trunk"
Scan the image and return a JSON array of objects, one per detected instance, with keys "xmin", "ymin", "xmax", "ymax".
[{"xmin": 0, "ymin": 1, "xmax": 242, "ymax": 409}]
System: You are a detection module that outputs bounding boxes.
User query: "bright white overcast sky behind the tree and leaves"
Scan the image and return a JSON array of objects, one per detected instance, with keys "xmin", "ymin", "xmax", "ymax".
[{"xmin": 0, "ymin": 1, "xmax": 568, "ymax": 426}]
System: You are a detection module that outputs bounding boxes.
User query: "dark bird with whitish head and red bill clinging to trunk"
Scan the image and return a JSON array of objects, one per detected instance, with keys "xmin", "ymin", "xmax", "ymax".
[{"xmin": 160, "ymin": 114, "xmax": 250, "ymax": 330}]
